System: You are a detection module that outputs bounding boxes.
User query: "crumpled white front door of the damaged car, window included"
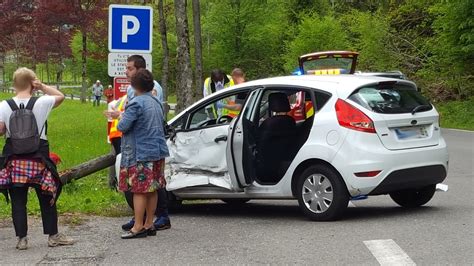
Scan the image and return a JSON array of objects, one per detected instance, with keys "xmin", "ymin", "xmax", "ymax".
[{"xmin": 167, "ymin": 88, "xmax": 248, "ymax": 191}]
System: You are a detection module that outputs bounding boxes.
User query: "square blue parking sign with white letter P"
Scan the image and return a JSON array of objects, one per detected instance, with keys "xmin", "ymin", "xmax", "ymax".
[{"xmin": 109, "ymin": 5, "xmax": 153, "ymax": 53}]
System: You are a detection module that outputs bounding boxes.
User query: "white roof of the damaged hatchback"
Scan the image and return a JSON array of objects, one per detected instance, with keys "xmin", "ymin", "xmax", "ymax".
[{"xmin": 170, "ymin": 74, "xmax": 416, "ymax": 122}]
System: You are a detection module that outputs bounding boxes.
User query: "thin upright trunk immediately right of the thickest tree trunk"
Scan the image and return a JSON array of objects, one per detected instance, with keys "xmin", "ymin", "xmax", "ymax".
[{"xmin": 193, "ymin": 0, "xmax": 204, "ymax": 98}]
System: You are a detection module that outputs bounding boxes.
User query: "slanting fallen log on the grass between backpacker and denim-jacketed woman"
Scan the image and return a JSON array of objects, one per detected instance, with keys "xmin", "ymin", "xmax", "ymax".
[{"xmin": 59, "ymin": 153, "xmax": 115, "ymax": 184}]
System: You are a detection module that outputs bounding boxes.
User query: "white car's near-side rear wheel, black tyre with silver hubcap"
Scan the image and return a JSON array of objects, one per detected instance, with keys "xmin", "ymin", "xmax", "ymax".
[{"xmin": 297, "ymin": 165, "xmax": 349, "ymax": 221}]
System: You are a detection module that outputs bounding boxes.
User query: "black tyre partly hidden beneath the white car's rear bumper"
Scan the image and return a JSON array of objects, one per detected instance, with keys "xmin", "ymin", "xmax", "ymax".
[{"xmin": 390, "ymin": 185, "xmax": 436, "ymax": 208}]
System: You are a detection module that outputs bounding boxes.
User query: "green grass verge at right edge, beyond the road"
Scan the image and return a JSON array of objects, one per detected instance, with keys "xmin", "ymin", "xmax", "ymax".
[{"xmin": 435, "ymin": 97, "xmax": 474, "ymax": 130}]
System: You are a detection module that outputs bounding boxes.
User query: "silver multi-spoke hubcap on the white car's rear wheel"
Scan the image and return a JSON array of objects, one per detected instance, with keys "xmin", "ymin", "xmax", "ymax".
[{"xmin": 301, "ymin": 174, "xmax": 334, "ymax": 213}]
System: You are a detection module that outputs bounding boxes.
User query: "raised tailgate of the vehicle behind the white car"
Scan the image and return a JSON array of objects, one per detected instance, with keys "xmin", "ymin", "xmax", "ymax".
[{"xmin": 298, "ymin": 51, "xmax": 359, "ymax": 75}]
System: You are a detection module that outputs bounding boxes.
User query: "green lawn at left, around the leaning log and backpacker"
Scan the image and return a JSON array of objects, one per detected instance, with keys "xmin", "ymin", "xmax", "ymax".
[{"xmin": 0, "ymin": 93, "xmax": 131, "ymax": 218}]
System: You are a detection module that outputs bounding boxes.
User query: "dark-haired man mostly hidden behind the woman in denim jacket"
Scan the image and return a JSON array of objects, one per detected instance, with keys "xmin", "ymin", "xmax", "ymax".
[{"xmin": 106, "ymin": 55, "xmax": 171, "ymax": 231}]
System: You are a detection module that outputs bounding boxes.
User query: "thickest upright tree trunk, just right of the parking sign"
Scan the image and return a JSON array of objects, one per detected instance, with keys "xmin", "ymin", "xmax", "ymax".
[{"xmin": 174, "ymin": 0, "xmax": 193, "ymax": 113}]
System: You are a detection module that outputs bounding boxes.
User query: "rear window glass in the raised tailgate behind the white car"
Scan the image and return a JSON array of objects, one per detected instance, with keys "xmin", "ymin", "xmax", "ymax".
[{"xmin": 303, "ymin": 56, "xmax": 353, "ymax": 75}]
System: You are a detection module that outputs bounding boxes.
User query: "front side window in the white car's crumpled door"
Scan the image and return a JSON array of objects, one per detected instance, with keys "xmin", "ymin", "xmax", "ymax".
[{"xmin": 188, "ymin": 92, "xmax": 248, "ymax": 129}]
